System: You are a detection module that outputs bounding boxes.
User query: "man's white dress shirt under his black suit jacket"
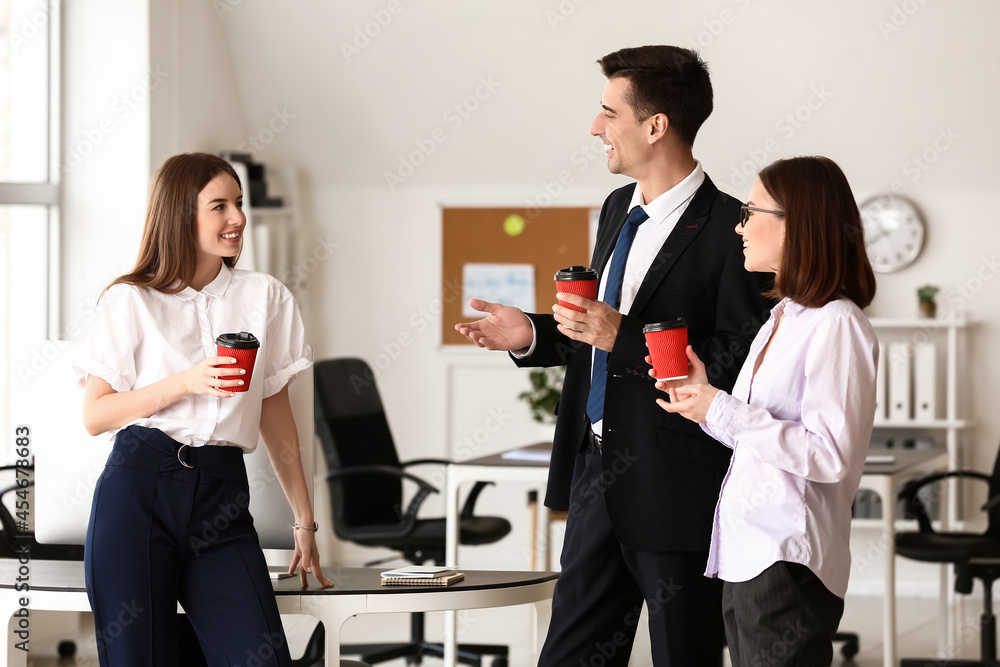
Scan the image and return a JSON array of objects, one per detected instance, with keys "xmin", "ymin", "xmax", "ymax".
[{"xmin": 514, "ymin": 162, "xmax": 705, "ymax": 435}]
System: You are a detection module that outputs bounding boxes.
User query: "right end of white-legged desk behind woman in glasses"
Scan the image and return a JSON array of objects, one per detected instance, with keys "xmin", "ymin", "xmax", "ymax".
[{"xmin": 845, "ymin": 448, "xmax": 948, "ymax": 665}]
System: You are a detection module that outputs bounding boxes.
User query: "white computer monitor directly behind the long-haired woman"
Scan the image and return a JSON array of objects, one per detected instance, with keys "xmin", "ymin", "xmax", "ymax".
[{"xmin": 17, "ymin": 341, "xmax": 315, "ymax": 549}]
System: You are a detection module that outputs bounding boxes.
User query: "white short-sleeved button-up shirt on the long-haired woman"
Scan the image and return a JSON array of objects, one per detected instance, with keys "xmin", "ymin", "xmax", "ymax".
[{"xmin": 74, "ymin": 265, "xmax": 312, "ymax": 452}]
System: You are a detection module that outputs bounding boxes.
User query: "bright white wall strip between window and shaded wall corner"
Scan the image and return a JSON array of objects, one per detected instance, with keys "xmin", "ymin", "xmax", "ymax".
[{"xmin": 60, "ymin": 0, "xmax": 151, "ymax": 338}]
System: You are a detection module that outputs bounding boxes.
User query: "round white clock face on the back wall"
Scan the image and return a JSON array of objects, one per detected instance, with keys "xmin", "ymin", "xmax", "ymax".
[{"xmin": 861, "ymin": 195, "xmax": 924, "ymax": 273}]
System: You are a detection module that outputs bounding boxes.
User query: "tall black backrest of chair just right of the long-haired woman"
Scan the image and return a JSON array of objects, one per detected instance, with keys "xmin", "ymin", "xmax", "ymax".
[{"xmin": 314, "ymin": 358, "xmax": 403, "ymax": 539}]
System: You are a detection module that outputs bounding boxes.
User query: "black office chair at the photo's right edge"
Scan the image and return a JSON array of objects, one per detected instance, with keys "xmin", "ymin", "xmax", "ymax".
[{"xmin": 896, "ymin": 444, "xmax": 1000, "ymax": 667}]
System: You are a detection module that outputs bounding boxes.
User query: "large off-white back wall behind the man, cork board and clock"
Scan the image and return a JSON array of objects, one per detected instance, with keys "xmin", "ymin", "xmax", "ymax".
[{"xmin": 58, "ymin": 0, "xmax": 1000, "ymax": 580}]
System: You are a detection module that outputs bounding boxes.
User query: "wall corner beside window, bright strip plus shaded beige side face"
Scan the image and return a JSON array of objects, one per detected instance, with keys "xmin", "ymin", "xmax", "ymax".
[{"xmin": 60, "ymin": 0, "xmax": 246, "ymax": 338}]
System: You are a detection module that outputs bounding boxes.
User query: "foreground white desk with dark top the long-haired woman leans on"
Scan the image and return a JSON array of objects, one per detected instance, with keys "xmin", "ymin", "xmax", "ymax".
[{"xmin": 0, "ymin": 560, "xmax": 558, "ymax": 667}]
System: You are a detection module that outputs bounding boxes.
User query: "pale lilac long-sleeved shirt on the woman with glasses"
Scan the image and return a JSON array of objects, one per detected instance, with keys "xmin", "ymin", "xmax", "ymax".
[{"xmin": 702, "ymin": 299, "xmax": 879, "ymax": 598}]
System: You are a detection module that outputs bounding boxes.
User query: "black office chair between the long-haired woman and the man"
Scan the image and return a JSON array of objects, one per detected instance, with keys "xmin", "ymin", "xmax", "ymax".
[{"xmin": 314, "ymin": 359, "xmax": 510, "ymax": 667}]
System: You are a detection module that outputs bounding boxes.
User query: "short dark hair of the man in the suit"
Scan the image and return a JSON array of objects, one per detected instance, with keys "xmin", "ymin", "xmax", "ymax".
[{"xmin": 597, "ymin": 46, "xmax": 712, "ymax": 146}]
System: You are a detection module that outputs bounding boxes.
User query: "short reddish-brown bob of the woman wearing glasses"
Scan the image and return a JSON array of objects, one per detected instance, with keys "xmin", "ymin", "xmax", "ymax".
[{"xmin": 760, "ymin": 156, "xmax": 875, "ymax": 308}]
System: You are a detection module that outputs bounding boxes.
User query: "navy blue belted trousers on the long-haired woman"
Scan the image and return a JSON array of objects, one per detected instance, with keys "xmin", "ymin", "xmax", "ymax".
[{"xmin": 84, "ymin": 426, "xmax": 291, "ymax": 667}]
